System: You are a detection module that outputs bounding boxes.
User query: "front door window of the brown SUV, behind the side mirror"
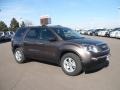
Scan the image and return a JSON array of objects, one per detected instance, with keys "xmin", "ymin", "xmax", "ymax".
[{"xmin": 40, "ymin": 28, "xmax": 55, "ymax": 40}]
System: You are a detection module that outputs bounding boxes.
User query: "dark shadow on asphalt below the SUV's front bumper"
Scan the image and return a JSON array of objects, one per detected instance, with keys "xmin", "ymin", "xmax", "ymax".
[{"xmin": 85, "ymin": 60, "xmax": 109, "ymax": 74}]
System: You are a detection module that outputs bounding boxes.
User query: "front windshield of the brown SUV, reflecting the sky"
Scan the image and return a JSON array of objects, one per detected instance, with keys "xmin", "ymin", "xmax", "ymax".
[{"xmin": 53, "ymin": 28, "xmax": 83, "ymax": 40}]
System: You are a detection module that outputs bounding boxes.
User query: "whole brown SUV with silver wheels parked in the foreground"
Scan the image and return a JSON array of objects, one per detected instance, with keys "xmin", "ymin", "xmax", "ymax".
[{"xmin": 12, "ymin": 26, "xmax": 110, "ymax": 76}]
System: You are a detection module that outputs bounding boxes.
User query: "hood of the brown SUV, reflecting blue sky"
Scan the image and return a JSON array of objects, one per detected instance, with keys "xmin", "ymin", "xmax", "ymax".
[{"xmin": 68, "ymin": 38, "xmax": 104, "ymax": 45}]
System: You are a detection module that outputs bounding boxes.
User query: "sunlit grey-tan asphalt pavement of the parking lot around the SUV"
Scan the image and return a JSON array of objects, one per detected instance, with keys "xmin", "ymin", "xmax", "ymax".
[{"xmin": 0, "ymin": 36, "xmax": 120, "ymax": 90}]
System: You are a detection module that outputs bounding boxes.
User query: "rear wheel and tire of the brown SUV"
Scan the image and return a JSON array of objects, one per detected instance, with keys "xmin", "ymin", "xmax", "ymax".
[{"xmin": 14, "ymin": 48, "xmax": 25, "ymax": 63}]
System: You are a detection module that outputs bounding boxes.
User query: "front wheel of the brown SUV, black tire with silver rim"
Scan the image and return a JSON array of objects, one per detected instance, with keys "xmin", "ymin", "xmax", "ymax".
[{"xmin": 61, "ymin": 53, "xmax": 82, "ymax": 76}]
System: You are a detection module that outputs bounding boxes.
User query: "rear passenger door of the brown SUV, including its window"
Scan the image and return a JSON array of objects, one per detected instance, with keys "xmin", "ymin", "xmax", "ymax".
[{"xmin": 24, "ymin": 28, "xmax": 42, "ymax": 58}]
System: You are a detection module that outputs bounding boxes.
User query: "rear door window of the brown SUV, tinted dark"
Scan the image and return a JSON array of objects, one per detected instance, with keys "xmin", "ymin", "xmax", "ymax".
[{"xmin": 25, "ymin": 28, "xmax": 40, "ymax": 40}]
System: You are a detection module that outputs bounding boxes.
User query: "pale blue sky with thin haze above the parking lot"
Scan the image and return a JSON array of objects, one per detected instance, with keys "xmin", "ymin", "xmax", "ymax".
[{"xmin": 0, "ymin": 0, "xmax": 120, "ymax": 29}]
